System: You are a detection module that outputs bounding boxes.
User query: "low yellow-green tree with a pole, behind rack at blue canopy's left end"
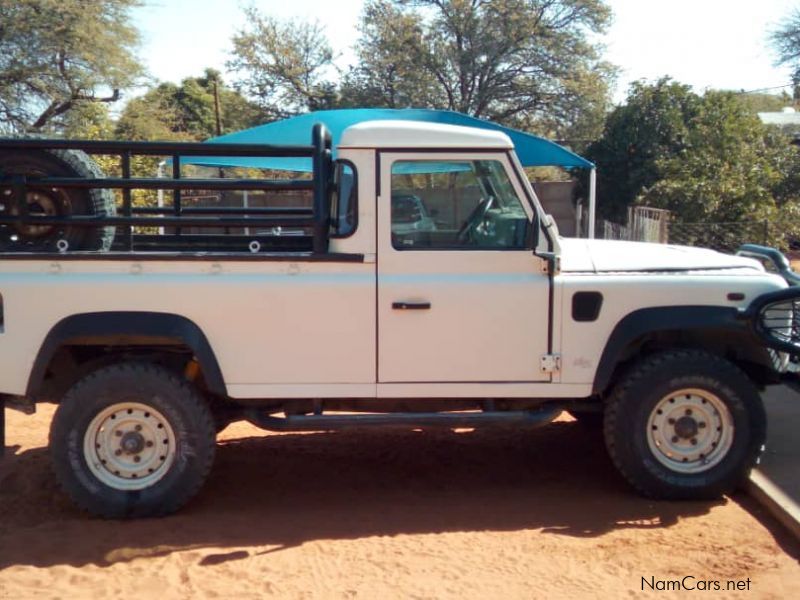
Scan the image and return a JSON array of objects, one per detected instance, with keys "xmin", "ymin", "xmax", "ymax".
[{"xmin": 116, "ymin": 69, "xmax": 266, "ymax": 140}]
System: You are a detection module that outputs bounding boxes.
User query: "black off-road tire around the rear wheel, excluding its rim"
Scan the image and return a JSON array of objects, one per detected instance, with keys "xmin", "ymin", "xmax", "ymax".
[{"xmin": 50, "ymin": 362, "xmax": 216, "ymax": 518}]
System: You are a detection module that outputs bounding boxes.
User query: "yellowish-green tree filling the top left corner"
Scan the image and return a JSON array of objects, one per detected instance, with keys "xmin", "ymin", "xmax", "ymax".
[{"xmin": 0, "ymin": 0, "xmax": 144, "ymax": 131}]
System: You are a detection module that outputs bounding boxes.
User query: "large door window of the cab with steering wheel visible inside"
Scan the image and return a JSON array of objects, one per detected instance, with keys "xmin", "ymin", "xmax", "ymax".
[{"xmin": 391, "ymin": 160, "xmax": 530, "ymax": 250}]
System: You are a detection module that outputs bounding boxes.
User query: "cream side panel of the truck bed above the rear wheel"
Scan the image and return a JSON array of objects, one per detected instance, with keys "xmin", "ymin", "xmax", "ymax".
[{"xmin": 0, "ymin": 261, "xmax": 376, "ymax": 394}]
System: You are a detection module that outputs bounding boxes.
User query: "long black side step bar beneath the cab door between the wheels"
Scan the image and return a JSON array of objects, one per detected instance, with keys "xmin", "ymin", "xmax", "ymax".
[{"xmin": 245, "ymin": 408, "xmax": 562, "ymax": 431}]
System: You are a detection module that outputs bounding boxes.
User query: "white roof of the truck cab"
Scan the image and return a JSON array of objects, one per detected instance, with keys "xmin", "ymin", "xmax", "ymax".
[{"xmin": 339, "ymin": 120, "xmax": 514, "ymax": 150}]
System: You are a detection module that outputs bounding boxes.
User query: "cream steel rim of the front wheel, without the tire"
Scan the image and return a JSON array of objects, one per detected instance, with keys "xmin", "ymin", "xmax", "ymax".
[{"xmin": 647, "ymin": 388, "xmax": 734, "ymax": 473}]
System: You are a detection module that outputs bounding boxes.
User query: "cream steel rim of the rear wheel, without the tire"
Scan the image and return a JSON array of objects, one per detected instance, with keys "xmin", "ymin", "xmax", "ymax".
[{"xmin": 83, "ymin": 402, "xmax": 176, "ymax": 490}]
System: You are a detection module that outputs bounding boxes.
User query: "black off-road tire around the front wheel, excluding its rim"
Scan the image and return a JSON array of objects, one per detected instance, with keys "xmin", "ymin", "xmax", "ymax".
[{"xmin": 603, "ymin": 350, "xmax": 766, "ymax": 500}]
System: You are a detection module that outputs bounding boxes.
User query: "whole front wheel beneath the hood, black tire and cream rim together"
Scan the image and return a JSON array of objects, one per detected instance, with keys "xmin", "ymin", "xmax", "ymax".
[{"xmin": 603, "ymin": 349, "xmax": 766, "ymax": 500}]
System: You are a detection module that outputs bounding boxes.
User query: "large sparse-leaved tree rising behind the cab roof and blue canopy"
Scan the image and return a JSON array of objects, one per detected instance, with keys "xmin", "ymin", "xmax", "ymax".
[{"xmin": 344, "ymin": 0, "xmax": 613, "ymax": 136}]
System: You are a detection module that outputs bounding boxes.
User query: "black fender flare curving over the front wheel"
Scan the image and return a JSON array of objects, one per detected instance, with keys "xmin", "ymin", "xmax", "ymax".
[{"xmin": 592, "ymin": 306, "xmax": 772, "ymax": 394}]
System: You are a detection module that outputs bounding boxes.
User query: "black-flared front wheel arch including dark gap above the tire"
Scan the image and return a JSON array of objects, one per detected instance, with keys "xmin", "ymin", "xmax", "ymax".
[{"xmin": 592, "ymin": 306, "xmax": 775, "ymax": 394}]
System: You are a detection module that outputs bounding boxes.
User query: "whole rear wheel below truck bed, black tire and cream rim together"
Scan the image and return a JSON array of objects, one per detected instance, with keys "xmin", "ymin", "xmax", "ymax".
[{"xmin": 50, "ymin": 361, "xmax": 216, "ymax": 518}]
